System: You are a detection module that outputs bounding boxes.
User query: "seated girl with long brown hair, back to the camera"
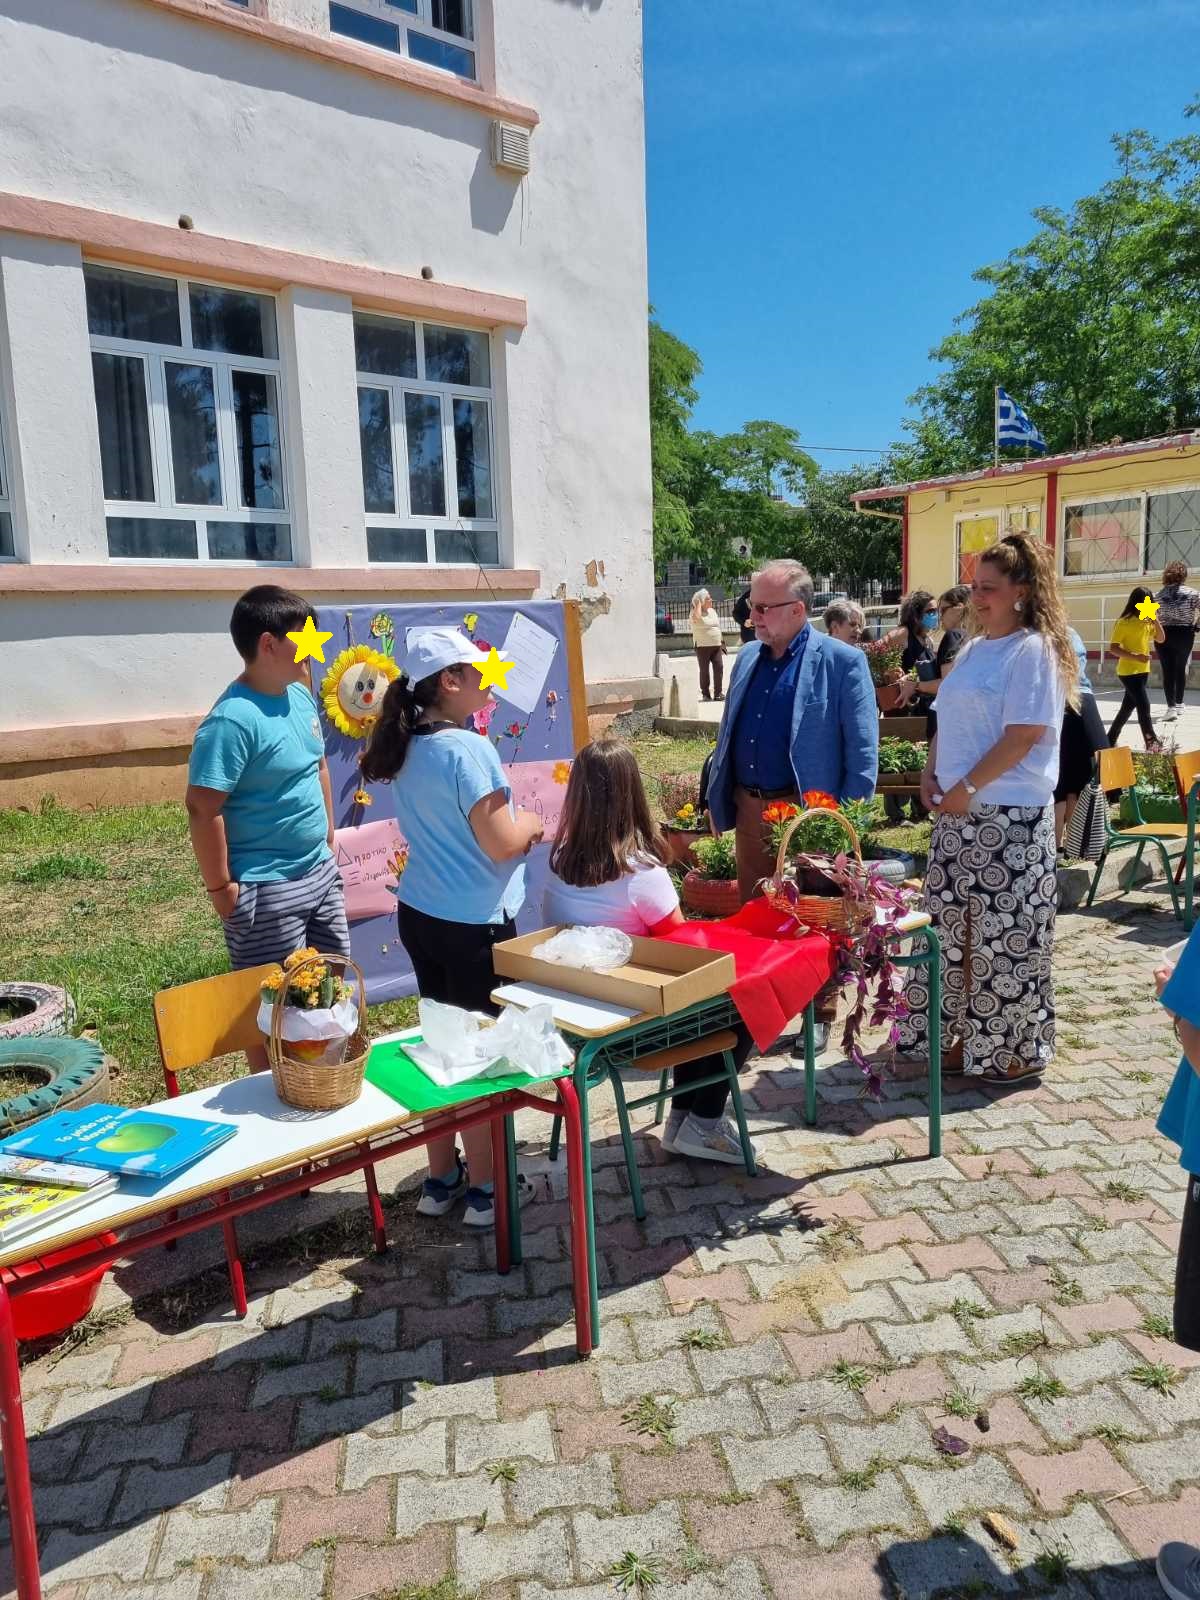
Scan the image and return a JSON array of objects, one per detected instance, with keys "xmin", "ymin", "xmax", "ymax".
[{"xmin": 542, "ymin": 739, "xmax": 750, "ymax": 1166}]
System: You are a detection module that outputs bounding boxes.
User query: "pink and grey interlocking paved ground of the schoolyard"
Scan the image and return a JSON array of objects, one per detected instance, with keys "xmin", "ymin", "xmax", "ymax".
[{"xmin": 3, "ymin": 893, "xmax": 1200, "ymax": 1600}]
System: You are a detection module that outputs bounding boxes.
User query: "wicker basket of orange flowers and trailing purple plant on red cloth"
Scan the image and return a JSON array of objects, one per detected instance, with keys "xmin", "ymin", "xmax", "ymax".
[{"xmin": 763, "ymin": 790, "xmax": 912, "ymax": 1098}]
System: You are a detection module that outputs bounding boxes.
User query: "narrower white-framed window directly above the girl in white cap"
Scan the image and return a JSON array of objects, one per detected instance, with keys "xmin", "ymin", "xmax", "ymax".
[{"xmin": 354, "ymin": 312, "xmax": 499, "ymax": 566}]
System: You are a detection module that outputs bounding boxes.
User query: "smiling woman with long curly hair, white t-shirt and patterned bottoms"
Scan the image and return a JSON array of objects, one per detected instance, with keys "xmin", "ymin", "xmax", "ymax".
[{"xmin": 901, "ymin": 533, "xmax": 1078, "ymax": 1083}]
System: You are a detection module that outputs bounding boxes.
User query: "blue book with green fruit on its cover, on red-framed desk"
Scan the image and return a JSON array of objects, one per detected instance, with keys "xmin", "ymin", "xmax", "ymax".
[{"xmin": 0, "ymin": 1104, "xmax": 237, "ymax": 1178}]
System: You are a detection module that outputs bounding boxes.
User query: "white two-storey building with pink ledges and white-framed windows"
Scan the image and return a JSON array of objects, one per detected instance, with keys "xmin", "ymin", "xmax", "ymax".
[{"xmin": 0, "ymin": 0, "xmax": 659, "ymax": 805}]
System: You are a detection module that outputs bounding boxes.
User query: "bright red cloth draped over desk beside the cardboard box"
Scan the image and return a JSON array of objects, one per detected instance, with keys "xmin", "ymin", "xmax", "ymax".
[{"xmin": 661, "ymin": 899, "xmax": 835, "ymax": 1050}]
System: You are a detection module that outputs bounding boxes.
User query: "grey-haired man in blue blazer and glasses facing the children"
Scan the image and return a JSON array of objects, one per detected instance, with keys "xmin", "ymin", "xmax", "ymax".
[{"xmin": 707, "ymin": 562, "xmax": 878, "ymax": 1049}]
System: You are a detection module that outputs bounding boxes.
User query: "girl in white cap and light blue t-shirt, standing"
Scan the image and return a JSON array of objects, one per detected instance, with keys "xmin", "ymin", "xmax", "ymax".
[{"xmin": 362, "ymin": 627, "xmax": 542, "ymax": 1227}]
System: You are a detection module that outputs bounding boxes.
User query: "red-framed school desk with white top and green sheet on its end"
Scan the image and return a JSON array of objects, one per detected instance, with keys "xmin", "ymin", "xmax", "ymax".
[{"xmin": 0, "ymin": 1034, "xmax": 592, "ymax": 1600}]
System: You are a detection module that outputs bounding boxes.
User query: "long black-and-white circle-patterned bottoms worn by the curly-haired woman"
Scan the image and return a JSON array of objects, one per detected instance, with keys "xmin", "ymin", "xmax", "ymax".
[{"xmin": 899, "ymin": 805, "xmax": 1058, "ymax": 1077}]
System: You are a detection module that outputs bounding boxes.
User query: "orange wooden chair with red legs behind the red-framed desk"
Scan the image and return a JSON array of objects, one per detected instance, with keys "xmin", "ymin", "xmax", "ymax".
[{"xmin": 154, "ymin": 962, "xmax": 387, "ymax": 1317}]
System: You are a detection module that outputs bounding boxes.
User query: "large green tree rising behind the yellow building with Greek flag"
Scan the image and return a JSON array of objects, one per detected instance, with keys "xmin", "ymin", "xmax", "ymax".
[{"xmin": 894, "ymin": 102, "xmax": 1200, "ymax": 478}]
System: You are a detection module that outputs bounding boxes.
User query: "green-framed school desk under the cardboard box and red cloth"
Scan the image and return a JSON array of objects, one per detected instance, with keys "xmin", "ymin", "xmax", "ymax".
[{"xmin": 491, "ymin": 910, "xmax": 942, "ymax": 1346}]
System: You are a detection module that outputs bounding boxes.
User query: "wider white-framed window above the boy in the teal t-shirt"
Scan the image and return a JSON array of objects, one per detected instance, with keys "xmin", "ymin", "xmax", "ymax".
[{"xmin": 83, "ymin": 264, "xmax": 291, "ymax": 562}]
